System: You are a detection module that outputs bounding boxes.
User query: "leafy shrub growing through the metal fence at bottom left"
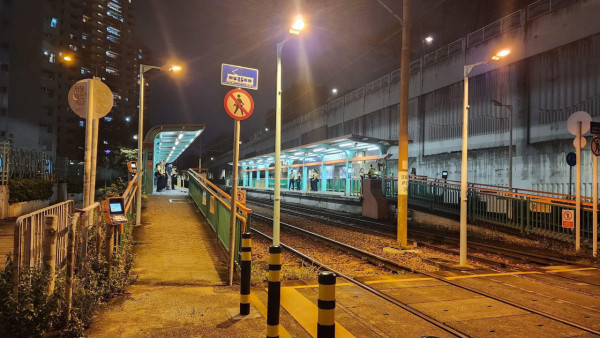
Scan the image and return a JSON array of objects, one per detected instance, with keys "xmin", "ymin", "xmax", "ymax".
[{"xmin": 0, "ymin": 222, "xmax": 134, "ymax": 337}]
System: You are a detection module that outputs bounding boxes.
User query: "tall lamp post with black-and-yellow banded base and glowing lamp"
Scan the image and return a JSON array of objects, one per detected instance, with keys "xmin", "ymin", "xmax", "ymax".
[{"xmin": 267, "ymin": 16, "xmax": 305, "ymax": 337}]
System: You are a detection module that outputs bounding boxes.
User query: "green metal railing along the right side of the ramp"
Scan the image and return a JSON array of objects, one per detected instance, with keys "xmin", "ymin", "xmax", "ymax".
[{"xmin": 188, "ymin": 169, "xmax": 252, "ymax": 264}]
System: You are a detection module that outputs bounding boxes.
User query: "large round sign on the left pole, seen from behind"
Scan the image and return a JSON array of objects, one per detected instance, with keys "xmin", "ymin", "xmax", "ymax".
[{"xmin": 68, "ymin": 77, "xmax": 114, "ymax": 119}]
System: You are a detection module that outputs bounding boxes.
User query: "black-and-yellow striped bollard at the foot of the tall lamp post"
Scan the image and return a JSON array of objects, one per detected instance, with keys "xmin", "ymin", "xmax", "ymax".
[{"xmin": 267, "ymin": 246, "xmax": 281, "ymax": 337}]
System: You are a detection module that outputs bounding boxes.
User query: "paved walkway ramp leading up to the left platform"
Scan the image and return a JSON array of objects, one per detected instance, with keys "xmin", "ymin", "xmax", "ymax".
[{"xmin": 86, "ymin": 192, "xmax": 266, "ymax": 337}]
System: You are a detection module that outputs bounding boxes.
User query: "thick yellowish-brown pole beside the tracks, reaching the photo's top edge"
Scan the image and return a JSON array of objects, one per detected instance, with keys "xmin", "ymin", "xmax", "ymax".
[{"xmin": 397, "ymin": 0, "xmax": 410, "ymax": 248}]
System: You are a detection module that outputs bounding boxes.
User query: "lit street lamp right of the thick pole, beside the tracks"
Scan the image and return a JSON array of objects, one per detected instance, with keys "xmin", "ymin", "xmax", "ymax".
[{"xmin": 458, "ymin": 49, "xmax": 510, "ymax": 266}]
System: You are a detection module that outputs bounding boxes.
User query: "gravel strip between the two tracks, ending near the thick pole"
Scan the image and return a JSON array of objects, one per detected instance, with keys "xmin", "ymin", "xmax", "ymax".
[{"xmin": 252, "ymin": 205, "xmax": 485, "ymax": 272}]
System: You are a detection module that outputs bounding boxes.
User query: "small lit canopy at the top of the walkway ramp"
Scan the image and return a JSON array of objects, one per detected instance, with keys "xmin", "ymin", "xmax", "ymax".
[{"xmin": 145, "ymin": 124, "xmax": 204, "ymax": 163}]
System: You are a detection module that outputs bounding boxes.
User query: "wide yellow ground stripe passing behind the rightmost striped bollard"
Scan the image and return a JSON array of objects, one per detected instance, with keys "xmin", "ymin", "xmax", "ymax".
[{"xmin": 281, "ymin": 288, "xmax": 354, "ymax": 337}]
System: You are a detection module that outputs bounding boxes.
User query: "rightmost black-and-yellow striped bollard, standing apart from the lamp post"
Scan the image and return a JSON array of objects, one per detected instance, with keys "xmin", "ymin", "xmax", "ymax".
[{"xmin": 317, "ymin": 271, "xmax": 335, "ymax": 338}]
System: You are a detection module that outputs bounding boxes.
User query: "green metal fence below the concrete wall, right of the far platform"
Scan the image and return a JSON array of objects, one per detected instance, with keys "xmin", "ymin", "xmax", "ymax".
[{"xmin": 384, "ymin": 176, "xmax": 593, "ymax": 244}]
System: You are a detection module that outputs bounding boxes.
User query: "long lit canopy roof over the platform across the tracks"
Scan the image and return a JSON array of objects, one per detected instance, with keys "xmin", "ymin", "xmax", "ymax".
[{"xmin": 234, "ymin": 135, "xmax": 398, "ymax": 168}]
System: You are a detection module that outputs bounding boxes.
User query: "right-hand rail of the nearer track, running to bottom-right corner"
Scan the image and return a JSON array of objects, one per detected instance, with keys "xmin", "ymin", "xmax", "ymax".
[{"xmin": 254, "ymin": 213, "xmax": 600, "ymax": 336}]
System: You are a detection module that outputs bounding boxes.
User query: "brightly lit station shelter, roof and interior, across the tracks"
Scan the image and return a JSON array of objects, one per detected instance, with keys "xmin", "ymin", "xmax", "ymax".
[{"xmin": 236, "ymin": 135, "xmax": 398, "ymax": 195}]
